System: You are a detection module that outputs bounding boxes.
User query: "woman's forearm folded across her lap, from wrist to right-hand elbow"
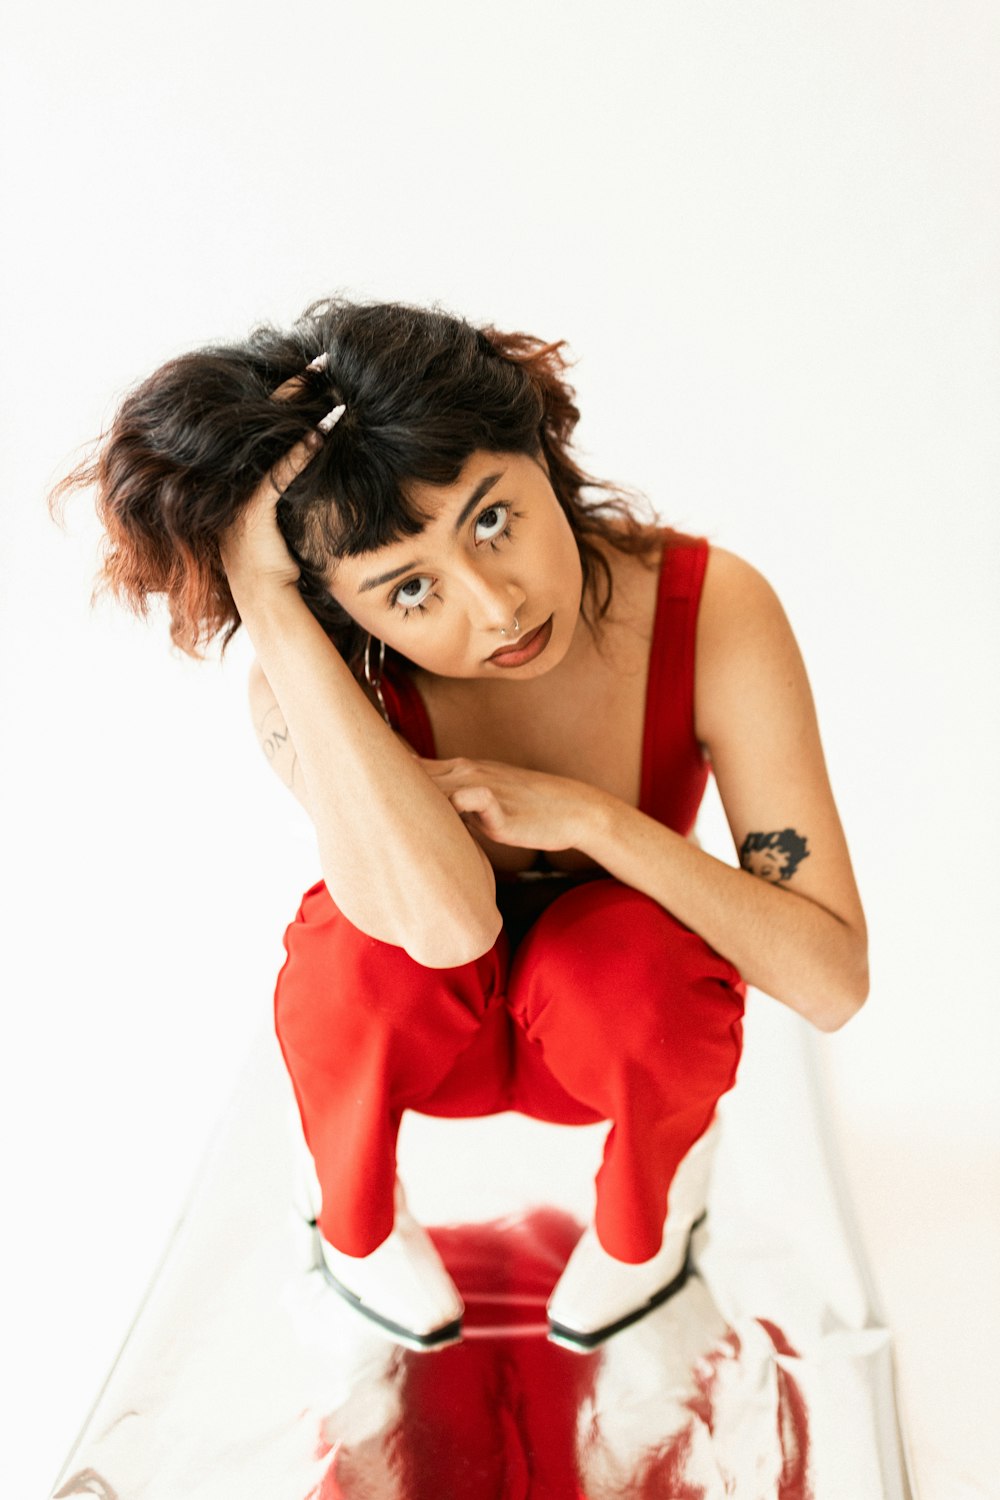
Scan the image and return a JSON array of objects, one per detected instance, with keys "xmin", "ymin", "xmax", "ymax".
[{"xmin": 577, "ymin": 791, "xmax": 868, "ymax": 1031}]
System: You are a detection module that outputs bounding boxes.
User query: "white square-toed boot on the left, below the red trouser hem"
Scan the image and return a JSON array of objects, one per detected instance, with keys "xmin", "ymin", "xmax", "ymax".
[{"xmin": 319, "ymin": 1178, "xmax": 465, "ymax": 1350}]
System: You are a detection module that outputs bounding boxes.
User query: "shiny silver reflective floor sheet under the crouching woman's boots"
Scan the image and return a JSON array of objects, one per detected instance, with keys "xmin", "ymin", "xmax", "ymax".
[{"xmin": 52, "ymin": 1008, "xmax": 912, "ymax": 1500}]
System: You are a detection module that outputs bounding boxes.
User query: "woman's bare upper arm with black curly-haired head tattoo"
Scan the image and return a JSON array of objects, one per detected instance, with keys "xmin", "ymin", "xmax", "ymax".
[{"xmin": 694, "ymin": 548, "xmax": 867, "ymax": 945}]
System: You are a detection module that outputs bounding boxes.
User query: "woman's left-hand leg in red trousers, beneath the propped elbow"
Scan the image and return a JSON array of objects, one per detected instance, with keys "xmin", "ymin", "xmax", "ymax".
[{"xmin": 274, "ymin": 882, "xmax": 510, "ymax": 1257}]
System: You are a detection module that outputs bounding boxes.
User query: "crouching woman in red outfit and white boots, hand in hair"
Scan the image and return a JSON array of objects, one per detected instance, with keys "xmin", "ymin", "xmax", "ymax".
[{"xmin": 52, "ymin": 299, "xmax": 868, "ymax": 1350}]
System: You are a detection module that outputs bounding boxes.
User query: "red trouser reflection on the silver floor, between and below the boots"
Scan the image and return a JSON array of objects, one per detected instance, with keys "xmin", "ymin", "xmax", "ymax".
[{"xmin": 309, "ymin": 1209, "xmax": 600, "ymax": 1500}]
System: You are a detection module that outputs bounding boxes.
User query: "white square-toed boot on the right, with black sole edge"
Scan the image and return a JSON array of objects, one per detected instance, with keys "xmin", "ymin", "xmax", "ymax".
[{"xmin": 546, "ymin": 1119, "xmax": 718, "ymax": 1353}]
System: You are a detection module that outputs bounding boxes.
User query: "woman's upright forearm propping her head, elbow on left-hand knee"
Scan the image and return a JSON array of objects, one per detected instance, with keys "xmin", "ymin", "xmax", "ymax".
[{"xmin": 232, "ymin": 584, "xmax": 501, "ymax": 968}]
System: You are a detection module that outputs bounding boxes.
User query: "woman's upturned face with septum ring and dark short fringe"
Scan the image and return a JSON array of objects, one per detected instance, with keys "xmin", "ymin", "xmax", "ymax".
[{"xmin": 325, "ymin": 450, "xmax": 583, "ymax": 681}]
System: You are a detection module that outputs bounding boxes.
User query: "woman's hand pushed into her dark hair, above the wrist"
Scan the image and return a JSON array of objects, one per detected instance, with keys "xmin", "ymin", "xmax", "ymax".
[{"xmin": 219, "ymin": 366, "xmax": 322, "ymax": 605}]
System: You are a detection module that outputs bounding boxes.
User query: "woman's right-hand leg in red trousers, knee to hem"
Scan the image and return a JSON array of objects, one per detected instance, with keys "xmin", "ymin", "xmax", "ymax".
[{"xmin": 508, "ymin": 879, "xmax": 745, "ymax": 1263}]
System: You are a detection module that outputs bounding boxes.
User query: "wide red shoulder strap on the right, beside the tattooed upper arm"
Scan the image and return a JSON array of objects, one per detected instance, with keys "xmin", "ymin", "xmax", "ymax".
[{"xmin": 639, "ymin": 528, "xmax": 709, "ymax": 837}]
